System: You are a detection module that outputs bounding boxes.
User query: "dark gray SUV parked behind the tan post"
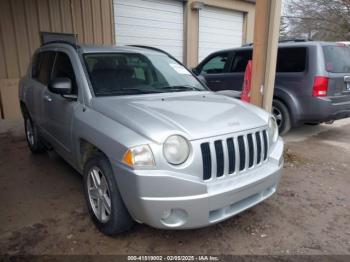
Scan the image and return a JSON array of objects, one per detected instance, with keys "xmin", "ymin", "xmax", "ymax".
[{"xmin": 193, "ymin": 41, "xmax": 350, "ymax": 134}]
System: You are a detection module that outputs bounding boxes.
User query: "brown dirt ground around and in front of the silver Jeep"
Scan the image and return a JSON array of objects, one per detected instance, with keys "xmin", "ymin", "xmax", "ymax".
[{"xmin": 0, "ymin": 120, "xmax": 350, "ymax": 255}]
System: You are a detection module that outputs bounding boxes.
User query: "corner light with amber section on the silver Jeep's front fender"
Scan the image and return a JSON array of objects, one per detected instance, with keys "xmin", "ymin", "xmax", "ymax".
[{"xmin": 123, "ymin": 145, "xmax": 155, "ymax": 167}]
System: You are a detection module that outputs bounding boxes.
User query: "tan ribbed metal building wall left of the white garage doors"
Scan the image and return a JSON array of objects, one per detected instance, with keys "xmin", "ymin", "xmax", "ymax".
[{"xmin": 0, "ymin": 0, "xmax": 114, "ymax": 118}]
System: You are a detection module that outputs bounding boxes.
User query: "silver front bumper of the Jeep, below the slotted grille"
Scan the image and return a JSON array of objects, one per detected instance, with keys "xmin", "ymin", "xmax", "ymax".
[{"xmin": 113, "ymin": 140, "xmax": 283, "ymax": 229}]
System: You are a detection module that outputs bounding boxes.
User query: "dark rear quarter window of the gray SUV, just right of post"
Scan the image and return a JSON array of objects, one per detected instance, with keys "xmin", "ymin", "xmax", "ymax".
[{"xmin": 276, "ymin": 47, "xmax": 306, "ymax": 73}]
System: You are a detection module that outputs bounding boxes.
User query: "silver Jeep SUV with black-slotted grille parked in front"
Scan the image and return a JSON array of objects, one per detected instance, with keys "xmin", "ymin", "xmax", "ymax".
[{"xmin": 19, "ymin": 35, "xmax": 283, "ymax": 235}]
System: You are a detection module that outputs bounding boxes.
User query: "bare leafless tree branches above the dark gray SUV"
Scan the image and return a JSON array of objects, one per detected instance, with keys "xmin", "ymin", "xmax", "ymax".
[{"xmin": 284, "ymin": 0, "xmax": 350, "ymax": 41}]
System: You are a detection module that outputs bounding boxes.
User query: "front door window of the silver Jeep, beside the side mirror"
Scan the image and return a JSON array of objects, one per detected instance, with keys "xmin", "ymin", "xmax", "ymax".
[{"xmin": 51, "ymin": 52, "xmax": 78, "ymax": 94}]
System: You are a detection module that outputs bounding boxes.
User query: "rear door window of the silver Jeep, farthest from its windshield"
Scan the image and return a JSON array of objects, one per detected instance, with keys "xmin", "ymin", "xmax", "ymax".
[{"xmin": 32, "ymin": 51, "xmax": 55, "ymax": 85}]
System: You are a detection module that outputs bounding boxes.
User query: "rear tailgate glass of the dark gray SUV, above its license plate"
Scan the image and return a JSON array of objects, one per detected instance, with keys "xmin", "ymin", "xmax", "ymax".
[{"xmin": 323, "ymin": 45, "xmax": 350, "ymax": 73}]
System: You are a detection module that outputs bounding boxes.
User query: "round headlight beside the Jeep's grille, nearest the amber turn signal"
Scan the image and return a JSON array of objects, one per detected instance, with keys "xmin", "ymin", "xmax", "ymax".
[{"xmin": 163, "ymin": 135, "xmax": 190, "ymax": 165}]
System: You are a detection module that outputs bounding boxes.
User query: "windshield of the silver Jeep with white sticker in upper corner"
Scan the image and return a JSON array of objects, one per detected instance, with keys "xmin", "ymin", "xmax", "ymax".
[{"xmin": 84, "ymin": 53, "xmax": 207, "ymax": 96}]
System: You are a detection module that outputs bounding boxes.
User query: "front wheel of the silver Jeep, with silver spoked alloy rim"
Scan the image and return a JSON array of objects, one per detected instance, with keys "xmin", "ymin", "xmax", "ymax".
[{"xmin": 84, "ymin": 153, "xmax": 134, "ymax": 235}]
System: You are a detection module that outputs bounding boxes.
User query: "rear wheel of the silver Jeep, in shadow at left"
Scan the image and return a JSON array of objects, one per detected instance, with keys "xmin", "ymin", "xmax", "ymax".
[{"xmin": 24, "ymin": 115, "xmax": 46, "ymax": 154}]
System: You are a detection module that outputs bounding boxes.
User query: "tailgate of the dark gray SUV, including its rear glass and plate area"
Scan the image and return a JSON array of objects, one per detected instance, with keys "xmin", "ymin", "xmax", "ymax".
[{"xmin": 322, "ymin": 44, "xmax": 350, "ymax": 99}]
